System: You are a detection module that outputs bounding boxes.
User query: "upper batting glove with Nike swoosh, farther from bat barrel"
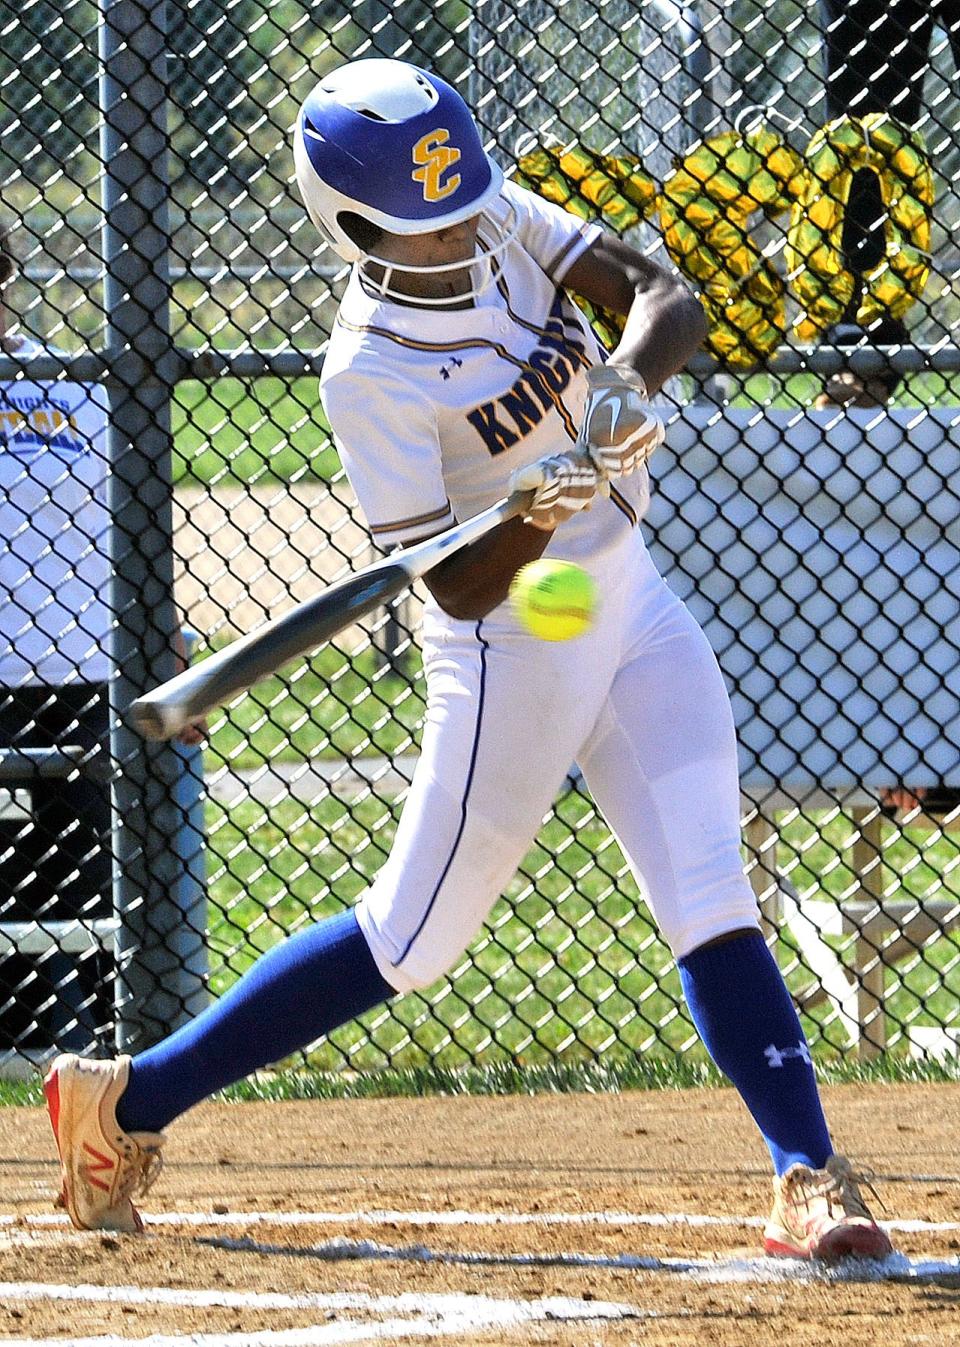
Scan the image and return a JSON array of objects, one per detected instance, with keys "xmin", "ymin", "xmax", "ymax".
[{"xmin": 576, "ymin": 365, "xmax": 664, "ymax": 481}]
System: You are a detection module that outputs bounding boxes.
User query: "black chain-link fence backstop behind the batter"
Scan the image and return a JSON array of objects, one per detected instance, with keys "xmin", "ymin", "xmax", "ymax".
[{"xmin": 0, "ymin": 0, "xmax": 960, "ymax": 1070}]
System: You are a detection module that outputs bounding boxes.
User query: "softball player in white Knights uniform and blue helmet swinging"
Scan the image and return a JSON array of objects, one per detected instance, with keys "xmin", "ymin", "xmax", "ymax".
[{"xmin": 46, "ymin": 61, "xmax": 890, "ymax": 1258}]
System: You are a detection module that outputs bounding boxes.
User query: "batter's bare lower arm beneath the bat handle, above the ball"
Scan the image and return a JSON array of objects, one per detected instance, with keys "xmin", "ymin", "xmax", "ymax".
[{"xmin": 424, "ymin": 519, "xmax": 553, "ymax": 621}]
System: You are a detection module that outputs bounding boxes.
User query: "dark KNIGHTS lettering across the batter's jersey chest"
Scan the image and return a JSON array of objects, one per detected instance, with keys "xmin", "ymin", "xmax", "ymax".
[{"xmin": 467, "ymin": 291, "xmax": 590, "ymax": 454}]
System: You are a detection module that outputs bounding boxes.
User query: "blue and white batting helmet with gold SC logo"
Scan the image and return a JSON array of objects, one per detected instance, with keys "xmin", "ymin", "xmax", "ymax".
[{"xmin": 294, "ymin": 59, "xmax": 509, "ymax": 299}]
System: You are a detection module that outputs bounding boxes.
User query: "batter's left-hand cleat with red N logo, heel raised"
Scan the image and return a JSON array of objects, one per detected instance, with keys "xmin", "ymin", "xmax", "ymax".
[{"xmin": 43, "ymin": 1052, "xmax": 164, "ymax": 1234}]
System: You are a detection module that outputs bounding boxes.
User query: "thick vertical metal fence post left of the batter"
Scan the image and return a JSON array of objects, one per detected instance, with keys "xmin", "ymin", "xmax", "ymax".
[{"xmin": 100, "ymin": 0, "xmax": 201, "ymax": 1052}]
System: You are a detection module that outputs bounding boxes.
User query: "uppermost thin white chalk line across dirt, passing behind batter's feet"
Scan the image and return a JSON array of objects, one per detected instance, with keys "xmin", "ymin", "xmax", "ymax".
[{"xmin": 0, "ymin": 1208, "xmax": 960, "ymax": 1234}]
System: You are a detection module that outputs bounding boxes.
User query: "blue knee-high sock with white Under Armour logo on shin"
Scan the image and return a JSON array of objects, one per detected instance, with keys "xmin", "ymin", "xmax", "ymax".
[{"xmin": 677, "ymin": 931, "xmax": 833, "ymax": 1175}]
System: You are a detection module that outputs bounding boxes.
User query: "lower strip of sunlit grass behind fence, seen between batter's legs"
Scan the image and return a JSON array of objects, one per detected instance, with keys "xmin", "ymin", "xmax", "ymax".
[{"xmin": 188, "ymin": 787, "xmax": 960, "ymax": 1071}]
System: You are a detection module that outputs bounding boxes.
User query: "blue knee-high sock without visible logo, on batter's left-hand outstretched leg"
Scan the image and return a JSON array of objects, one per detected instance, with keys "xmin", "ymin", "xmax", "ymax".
[{"xmin": 117, "ymin": 911, "xmax": 396, "ymax": 1131}]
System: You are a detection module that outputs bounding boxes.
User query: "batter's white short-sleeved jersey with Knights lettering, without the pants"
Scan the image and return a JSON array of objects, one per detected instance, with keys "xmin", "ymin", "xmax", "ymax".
[{"xmin": 320, "ymin": 183, "xmax": 649, "ymax": 568}]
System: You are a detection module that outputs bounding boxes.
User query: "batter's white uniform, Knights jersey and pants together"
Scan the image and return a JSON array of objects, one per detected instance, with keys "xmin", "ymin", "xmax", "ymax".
[{"xmin": 320, "ymin": 185, "xmax": 757, "ymax": 991}]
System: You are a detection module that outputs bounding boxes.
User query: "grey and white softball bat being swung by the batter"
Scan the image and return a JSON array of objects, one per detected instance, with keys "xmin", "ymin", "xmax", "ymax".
[{"xmin": 128, "ymin": 490, "xmax": 533, "ymax": 740}]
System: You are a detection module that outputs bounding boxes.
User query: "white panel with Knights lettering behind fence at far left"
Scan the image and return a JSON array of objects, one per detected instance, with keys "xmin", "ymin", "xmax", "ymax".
[{"xmin": 0, "ymin": 346, "xmax": 110, "ymax": 687}]
